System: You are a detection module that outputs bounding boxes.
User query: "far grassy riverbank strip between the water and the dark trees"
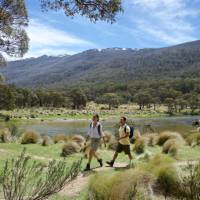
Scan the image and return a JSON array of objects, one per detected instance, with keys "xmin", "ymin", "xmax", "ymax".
[{"xmin": 0, "ymin": 104, "xmax": 200, "ymax": 121}]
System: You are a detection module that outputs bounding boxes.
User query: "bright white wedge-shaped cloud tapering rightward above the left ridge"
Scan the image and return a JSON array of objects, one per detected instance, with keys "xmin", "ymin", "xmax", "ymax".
[{"xmin": 25, "ymin": 19, "xmax": 95, "ymax": 57}]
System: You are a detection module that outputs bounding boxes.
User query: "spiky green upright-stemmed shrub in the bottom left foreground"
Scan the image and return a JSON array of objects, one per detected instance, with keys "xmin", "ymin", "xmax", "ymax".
[{"xmin": 1, "ymin": 151, "xmax": 81, "ymax": 200}]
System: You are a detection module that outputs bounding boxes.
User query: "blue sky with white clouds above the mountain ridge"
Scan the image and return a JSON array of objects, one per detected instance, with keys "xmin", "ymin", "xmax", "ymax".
[{"xmin": 20, "ymin": 0, "xmax": 200, "ymax": 58}]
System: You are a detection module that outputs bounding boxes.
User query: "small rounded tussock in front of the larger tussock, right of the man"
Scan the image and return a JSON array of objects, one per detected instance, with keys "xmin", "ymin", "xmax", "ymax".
[{"xmin": 162, "ymin": 139, "xmax": 179, "ymax": 156}]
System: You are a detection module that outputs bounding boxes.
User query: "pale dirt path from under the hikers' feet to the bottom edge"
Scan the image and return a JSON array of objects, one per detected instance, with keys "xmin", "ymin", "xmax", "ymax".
[{"xmin": 60, "ymin": 163, "xmax": 127, "ymax": 199}]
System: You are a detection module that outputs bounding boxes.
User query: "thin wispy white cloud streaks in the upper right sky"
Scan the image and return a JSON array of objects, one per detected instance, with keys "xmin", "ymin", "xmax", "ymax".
[{"xmin": 127, "ymin": 0, "xmax": 199, "ymax": 45}]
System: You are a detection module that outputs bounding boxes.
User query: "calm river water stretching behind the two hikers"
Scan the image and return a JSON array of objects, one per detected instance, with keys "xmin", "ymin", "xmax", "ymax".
[{"xmin": 20, "ymin": 116, "xmax": 200, "ymax": 135}]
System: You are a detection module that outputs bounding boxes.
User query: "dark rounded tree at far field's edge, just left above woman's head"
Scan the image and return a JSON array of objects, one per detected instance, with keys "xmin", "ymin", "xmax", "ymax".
[{"xmin": 69, "ymin": 88, "xmax": 87, "ymax": 109}]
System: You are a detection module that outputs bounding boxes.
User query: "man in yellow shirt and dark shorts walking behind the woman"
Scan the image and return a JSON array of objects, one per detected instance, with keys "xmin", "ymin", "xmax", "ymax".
[{"xmin": 106, "ymin": 117, "xmax": 133, "ymax": 167}]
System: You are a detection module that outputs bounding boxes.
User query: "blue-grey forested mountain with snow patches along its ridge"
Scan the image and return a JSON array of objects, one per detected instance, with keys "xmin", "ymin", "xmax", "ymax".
[{"xmin": 0, "ymin": 40, "xmax": 200, "ymax": 87}]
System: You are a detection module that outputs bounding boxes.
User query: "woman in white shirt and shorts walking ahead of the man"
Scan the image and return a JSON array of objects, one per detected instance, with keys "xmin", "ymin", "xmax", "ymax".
[{"xmin": 84, "ymin": 114, "xmax": 105, "ymax": 171}]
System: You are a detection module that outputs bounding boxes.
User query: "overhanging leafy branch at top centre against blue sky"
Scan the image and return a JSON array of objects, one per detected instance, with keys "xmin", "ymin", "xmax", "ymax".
[{"xmin": 41, "ymin": 0, "xmax": 122, "ymax": 23}]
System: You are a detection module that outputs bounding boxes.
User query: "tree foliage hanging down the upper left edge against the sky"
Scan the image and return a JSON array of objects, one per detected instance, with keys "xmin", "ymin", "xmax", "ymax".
[{"xmin": 0, "ymin": 0, "xmax": 29, "ymax": 65}]
